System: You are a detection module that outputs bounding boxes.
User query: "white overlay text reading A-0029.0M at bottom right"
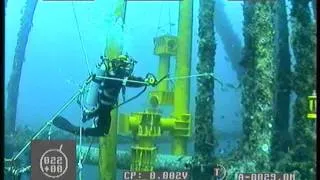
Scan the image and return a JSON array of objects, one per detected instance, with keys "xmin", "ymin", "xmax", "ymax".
[{"xmin": 237, "ymin": 173, "xmax": 296, "ymax": 180}]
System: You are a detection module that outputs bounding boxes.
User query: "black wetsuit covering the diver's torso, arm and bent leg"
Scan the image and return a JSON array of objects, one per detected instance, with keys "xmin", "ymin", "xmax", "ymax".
[{"xmin": 83, "ymin": 73, "xmax": 145, "ymax": 136}]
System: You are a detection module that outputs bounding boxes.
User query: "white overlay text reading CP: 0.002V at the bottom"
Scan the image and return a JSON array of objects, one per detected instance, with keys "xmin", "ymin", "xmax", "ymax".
[{"xmin": 123, "ymin": 171, "xmax": 190, "ymax": 180}]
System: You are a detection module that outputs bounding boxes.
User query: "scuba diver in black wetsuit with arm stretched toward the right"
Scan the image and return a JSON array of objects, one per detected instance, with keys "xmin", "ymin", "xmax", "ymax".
[{"xmin": 52, "ymin": 55, "xmax": 157, "ymax": 137}]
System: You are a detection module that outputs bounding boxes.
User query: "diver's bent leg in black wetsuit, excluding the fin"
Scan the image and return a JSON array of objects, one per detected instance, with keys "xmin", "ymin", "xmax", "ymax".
[{"xmin": 84, "ymin": 110, "xmax": 111, "ymax": 137}]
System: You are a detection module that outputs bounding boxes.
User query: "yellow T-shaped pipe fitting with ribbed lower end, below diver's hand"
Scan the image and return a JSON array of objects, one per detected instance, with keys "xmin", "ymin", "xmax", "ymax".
[{"xmin": 120, "ymin": 112, "xmax": 191, "ymax": 172}]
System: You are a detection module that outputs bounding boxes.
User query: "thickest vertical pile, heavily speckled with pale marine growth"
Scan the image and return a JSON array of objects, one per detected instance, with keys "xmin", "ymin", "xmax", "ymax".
[{"xmin": 241, "ymin": 1, "xmax": 275, "ymax": 172}]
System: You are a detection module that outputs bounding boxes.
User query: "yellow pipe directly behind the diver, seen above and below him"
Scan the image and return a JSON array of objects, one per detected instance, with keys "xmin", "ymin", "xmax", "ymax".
[{"xmin": 99, "ymin": 0, "xmax": 126, "ymax": 180}]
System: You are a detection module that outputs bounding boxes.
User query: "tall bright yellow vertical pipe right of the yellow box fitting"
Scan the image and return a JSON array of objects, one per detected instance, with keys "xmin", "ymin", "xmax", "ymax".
[{"xmin": 172, "ymin": 0, "xmax": 193, "ymax": 155}]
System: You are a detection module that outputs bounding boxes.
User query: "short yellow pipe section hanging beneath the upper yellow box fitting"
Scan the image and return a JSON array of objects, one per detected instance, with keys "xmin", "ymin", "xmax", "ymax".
[{"xmin": 157, "ymin": 55, "xmax": 170, "ymax": 91}]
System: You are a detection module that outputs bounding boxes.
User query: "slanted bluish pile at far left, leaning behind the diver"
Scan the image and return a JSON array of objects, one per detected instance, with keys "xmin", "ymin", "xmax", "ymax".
[{"xmin": 5, "ymin": 0, "xmax": 38, "ymax": 133}]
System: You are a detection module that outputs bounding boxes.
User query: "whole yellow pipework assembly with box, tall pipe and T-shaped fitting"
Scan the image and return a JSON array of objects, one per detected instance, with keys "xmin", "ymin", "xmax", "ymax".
[{"xmin": 118, "ymin": 0, "xmax": 193, "ymax": 172}]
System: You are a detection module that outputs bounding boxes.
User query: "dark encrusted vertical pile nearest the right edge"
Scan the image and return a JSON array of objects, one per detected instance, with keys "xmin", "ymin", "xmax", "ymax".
[{"xmin": 289, "ymin": 0, "xmax": 316, "ymax": 179}]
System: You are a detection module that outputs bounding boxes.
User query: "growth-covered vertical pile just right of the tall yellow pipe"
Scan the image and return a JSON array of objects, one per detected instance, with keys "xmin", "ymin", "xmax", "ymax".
[{"xmin": 192, "ymin": 0, "xmax": 216, "ymax": 180}]
